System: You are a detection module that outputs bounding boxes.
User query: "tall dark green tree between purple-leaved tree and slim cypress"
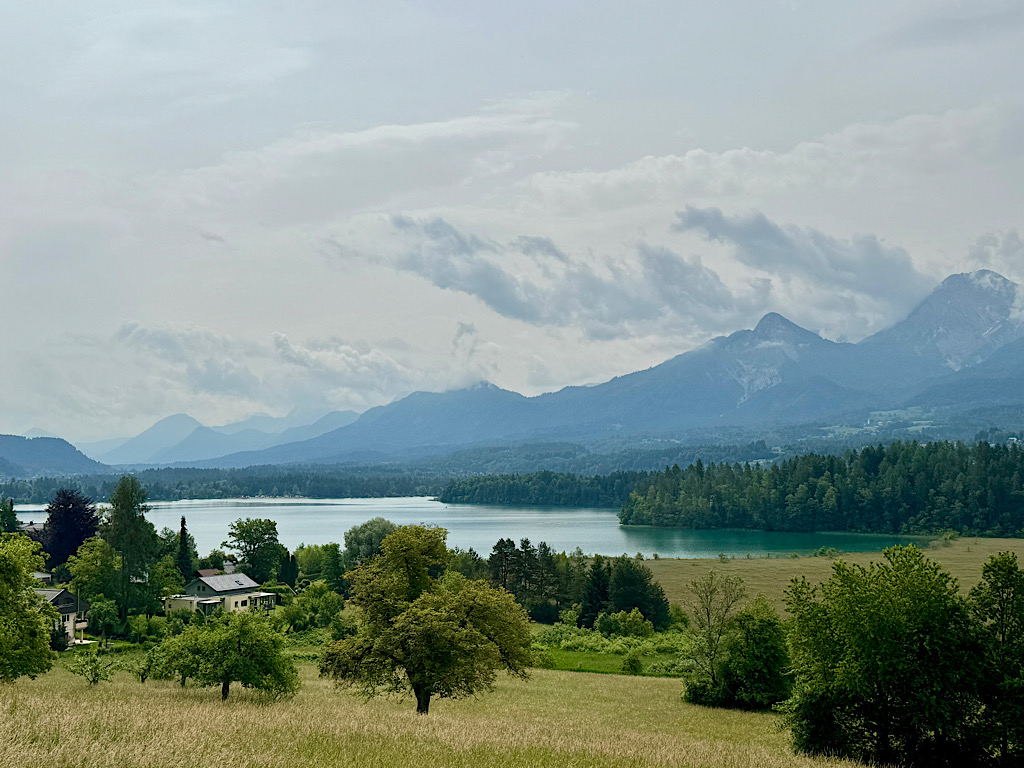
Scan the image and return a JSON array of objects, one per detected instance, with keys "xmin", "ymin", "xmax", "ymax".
[{"xmin": 99, "ymin": 475, "xmax": 160, "ymax": 617}]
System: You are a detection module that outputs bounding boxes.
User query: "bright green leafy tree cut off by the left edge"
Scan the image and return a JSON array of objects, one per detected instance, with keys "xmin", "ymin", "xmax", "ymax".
[{"xmin": 0, "ymin": 534, "xmax": 57, "ymax": 682}]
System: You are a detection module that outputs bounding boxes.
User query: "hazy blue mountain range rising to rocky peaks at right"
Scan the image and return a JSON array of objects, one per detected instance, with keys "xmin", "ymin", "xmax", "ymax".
[{"xmin": 0, "ymin": 270, "xmax": 1024, "ymax": 474}]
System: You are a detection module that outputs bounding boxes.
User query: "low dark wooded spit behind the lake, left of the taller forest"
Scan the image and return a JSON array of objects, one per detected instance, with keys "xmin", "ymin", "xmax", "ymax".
[{"xmin": 440, "ymin": 471, "xmax": 648, "ymax": 507}]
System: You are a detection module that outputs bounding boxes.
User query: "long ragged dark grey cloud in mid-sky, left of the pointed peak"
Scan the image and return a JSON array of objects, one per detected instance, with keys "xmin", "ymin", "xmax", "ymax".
[{"xmin": 379, "ymin": 216, "xmax": 766, "ymax": 339}]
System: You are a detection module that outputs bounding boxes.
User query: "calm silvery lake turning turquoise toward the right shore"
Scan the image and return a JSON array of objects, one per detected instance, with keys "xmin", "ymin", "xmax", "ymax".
[{"xmin": 15, "ymin": 497, "xmax": 920, "ymax": 558}]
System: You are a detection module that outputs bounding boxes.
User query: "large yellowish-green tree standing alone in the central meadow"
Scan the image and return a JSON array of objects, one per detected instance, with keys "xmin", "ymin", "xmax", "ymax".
[{"xmin": 321, "ymin": 525, "xmax": 530, "ymax": 714}]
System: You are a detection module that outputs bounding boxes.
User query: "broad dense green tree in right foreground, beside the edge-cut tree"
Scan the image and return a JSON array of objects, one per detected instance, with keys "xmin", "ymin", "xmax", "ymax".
[{"xmin": 786, "ymin": 547, "xmax": 983, "ymax": 766}]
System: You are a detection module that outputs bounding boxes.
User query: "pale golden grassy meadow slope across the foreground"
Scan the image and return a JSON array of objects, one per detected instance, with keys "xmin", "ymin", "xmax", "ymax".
[{"xmin": 0, "ymin": 665, "xmax": 852, "ymax": 768}]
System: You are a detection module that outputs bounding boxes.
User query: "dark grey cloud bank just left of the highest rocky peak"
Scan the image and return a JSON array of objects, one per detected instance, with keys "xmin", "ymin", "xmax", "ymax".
[{"xmin": 673, "ymin": 207, "xmax": 934, "ymax": 307}]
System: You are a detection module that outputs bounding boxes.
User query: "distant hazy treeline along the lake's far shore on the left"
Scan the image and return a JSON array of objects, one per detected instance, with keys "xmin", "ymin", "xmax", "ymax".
[{"xmin": 0, "ymin": 467, "xmax": 445, "ymax": 504}]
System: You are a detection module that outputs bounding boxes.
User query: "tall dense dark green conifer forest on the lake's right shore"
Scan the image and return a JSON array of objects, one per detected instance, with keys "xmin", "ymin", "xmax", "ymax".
[{"xmin": 620, "ymin": 441, "xmax": 1024, "ymax": 537}]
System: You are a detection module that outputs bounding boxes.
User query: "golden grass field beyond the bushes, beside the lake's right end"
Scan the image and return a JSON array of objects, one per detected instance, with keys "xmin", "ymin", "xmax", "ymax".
[{"xmin": 644, "ymin": 539, "xmax": 1024, "ymax": 609}]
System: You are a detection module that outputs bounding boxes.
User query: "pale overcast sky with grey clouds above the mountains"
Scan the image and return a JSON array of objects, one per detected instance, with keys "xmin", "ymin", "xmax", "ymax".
[{"xmin": 0, "ymin": 0, "xmax": 1024, "ymax": 441}]
